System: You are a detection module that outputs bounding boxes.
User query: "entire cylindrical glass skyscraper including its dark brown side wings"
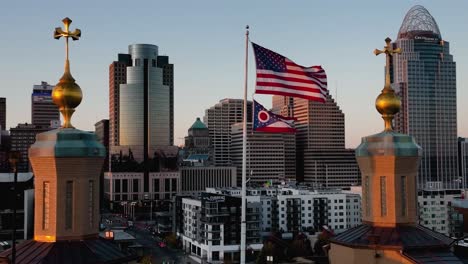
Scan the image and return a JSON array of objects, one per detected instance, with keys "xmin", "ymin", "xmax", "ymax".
[{"xmin": 109, "ymin": 44, "xmax": 177, "ymax": 198}]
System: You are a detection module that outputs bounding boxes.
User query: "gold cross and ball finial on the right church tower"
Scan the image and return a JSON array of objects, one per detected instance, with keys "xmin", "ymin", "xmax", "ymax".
[{"xmin": 374, "ymin": 38, "xmax": 401, "ymax": 132}]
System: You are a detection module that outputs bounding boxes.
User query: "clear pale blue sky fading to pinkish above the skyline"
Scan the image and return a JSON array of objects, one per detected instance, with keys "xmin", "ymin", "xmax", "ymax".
[{"xmin": 0, "ymin": 0, "xmax": 468, "ymax": 147}]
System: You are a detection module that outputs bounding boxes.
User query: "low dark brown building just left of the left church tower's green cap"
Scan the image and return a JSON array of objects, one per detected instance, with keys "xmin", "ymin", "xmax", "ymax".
[{"xmin": 10, "ymin": 123, "xmax": 50, "ymax": 172}]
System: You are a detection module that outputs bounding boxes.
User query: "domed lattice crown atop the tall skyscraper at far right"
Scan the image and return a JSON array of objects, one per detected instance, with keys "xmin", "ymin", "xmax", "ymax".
[{"xmin": 398, "ymin": 5, "xmax": 442, "ymax": 39}]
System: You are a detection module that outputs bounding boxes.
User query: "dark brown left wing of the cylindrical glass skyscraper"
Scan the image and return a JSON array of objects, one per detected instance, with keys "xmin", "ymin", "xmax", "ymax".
[{"xmin": 109, "ymin": 54, "xmax": 132, "ymax": 146}]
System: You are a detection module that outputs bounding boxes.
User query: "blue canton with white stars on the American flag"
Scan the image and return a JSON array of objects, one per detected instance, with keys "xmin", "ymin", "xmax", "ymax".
[{"xmin": 252, "ymin": 42, "xmax": 286, "ymax": 72}]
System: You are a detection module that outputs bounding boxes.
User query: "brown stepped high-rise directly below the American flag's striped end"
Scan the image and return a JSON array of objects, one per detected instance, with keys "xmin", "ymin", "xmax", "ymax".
[{"xmin": 272, "ymin": 95, "xmax": 360, "ymax": 187}]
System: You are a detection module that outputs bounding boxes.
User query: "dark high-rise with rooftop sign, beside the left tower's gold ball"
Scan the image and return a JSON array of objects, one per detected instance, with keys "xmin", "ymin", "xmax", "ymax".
[{"xmin": 31, "ymin": 82, "xmax": 60, "ymax": 127}]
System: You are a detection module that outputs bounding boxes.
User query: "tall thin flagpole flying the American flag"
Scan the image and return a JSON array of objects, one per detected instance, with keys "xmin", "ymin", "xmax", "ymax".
[{"xmin": 240, "ymin": 25, "xmax": 249, "ymax": 264}]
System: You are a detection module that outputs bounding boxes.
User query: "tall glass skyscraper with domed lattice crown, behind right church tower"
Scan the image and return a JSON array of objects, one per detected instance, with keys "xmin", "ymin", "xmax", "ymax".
[{"xmin": 391, "ymin": 5, "xmax": 461, "ymax": 188}]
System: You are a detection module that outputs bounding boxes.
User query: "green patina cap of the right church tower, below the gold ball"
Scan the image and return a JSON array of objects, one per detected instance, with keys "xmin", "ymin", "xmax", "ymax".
[{"xmin": 356, "ymin": 131, "xmax": 422, "ymax": 157}]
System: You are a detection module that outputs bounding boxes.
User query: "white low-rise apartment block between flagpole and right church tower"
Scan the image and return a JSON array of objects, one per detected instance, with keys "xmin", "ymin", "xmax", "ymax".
[{"xmin": 206, "ymin": 184, "xmax": 361, "ymax": 234}]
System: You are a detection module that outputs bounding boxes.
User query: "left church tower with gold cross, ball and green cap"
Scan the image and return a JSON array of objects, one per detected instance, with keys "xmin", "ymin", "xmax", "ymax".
[{"xmin": 0, "ymin": 18, "xmax": 137, "ymax": 264}]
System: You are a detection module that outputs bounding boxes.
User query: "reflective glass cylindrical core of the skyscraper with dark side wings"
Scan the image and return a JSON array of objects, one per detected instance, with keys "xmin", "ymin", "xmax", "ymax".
[{"xmin": 119, "ymin": 44, "xmax": 172, "ymax": 146}]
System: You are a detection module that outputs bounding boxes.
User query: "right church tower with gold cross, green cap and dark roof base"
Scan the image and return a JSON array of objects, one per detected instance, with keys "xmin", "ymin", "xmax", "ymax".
[{"xmin": 327, "ymin": 33, "xmax": 462, "ymax": 264}]
